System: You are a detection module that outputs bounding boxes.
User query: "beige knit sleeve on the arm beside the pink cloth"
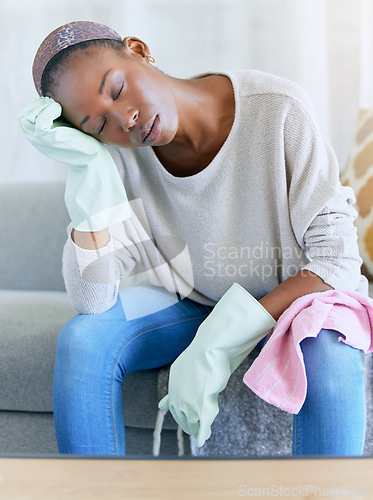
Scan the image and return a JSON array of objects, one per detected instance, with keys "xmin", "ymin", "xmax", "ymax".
[{"xmin": 284, "ymin": 89, "xmax": 362, "ymax": 290}]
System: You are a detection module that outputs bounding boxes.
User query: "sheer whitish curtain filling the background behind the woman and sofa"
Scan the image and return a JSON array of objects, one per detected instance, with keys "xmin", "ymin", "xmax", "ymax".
[{"xmin": 0, "ymin": 0, "xmax": 373, "ymax": 183}]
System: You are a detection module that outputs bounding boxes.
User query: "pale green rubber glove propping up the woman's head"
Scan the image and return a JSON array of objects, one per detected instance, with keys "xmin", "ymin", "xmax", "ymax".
[{"xmin": 18, "ymin": 97, "xmax": 130, "ymax": 231}]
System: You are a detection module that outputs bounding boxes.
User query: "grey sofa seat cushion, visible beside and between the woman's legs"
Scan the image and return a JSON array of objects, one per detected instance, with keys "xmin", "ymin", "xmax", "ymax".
[{"xmin": 0, "ymin": 290, "xmax": 177, "ymax": 429}]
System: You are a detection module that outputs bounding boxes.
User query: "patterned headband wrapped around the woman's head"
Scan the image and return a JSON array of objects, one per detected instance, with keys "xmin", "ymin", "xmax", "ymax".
[{"xmin": 32, "ymin": 21, "xmax": 122, "ymax": 96}]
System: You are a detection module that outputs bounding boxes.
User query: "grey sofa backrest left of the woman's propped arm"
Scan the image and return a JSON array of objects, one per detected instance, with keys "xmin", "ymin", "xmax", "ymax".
[{"xmin": 0, "ymin": 182, "xmax": 70, "ymax": 290}]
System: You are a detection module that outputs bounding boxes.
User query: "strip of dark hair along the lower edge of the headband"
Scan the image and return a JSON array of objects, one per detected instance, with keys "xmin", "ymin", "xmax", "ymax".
[{"xmin": 41, "ymin": 38, "xmax": 123, "ymax": 97}]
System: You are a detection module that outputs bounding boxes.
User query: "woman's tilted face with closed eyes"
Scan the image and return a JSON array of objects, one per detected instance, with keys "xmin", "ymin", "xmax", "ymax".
[{"xmin": 53, "ymin": 41, "xmax": 178, "ymax": 148}]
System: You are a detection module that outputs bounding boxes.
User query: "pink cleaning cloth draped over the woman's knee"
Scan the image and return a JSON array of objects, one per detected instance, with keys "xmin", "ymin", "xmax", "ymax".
[{"xmin": 243, "ymin": 290, "xmax": 373, "ymax": 413}]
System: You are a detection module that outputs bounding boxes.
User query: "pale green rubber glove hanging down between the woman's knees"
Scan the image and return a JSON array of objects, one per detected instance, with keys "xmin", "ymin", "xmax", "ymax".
[{"xmin": 158, "ymin": 283, "xmax": 276, "ymax": 446}]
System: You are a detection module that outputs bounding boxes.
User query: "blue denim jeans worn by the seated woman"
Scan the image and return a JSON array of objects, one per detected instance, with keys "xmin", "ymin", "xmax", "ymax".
[{"xmin": 53, "ymin": 286, "xmax": 366, "ymax": 455}]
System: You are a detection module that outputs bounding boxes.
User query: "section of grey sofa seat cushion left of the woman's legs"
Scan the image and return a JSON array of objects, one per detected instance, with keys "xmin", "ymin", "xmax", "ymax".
[{"xmin": 0, "ymin": 290, "xmax": 76, "ymax": 411}]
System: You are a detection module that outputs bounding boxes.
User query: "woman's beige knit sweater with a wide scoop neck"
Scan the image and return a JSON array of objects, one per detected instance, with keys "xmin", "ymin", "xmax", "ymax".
[{"xmin": 63, "ymin": 71, "xmax": 367, "ymax": 314}]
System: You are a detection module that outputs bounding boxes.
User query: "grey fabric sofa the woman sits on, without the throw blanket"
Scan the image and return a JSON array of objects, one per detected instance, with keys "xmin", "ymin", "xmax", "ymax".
[{"xmin": 0, "ymin": 183, "xmax": 186, "ymax": 455}]
